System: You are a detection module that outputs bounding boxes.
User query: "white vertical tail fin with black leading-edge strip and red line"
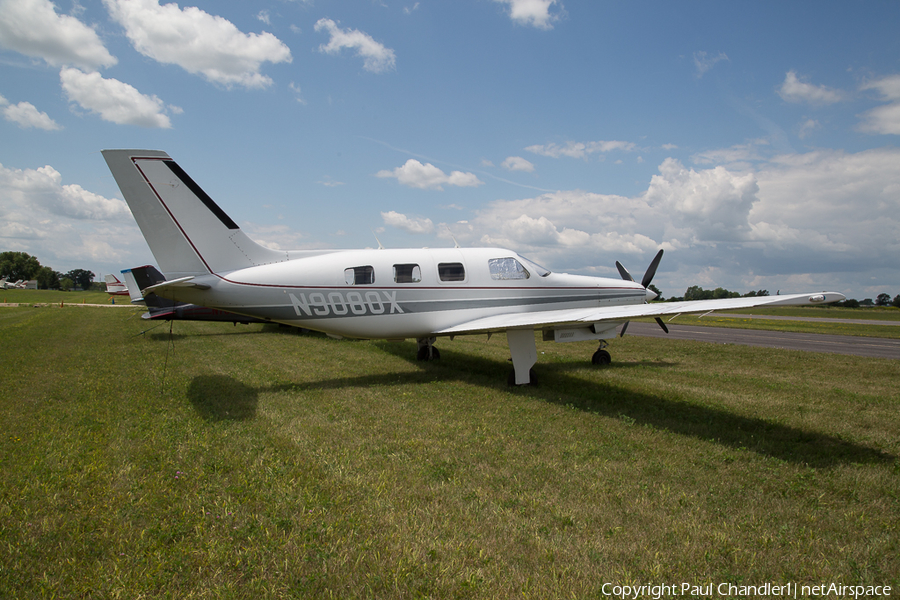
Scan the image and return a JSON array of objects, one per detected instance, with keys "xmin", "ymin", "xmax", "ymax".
[{"xmin": 103, "ymin": 150, "xmax": 287, "ymax": 279}]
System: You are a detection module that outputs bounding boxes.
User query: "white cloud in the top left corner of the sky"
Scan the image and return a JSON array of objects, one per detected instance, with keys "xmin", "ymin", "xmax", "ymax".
[{"xmin": 0, "ymin": 0, "xmax": 116, "ymax": 69}]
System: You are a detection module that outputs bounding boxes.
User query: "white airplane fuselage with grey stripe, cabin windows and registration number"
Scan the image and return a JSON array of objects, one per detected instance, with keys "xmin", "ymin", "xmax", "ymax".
[{"xmin": 159, "ymin": 248, "xmax": 647, "ymax": 339}]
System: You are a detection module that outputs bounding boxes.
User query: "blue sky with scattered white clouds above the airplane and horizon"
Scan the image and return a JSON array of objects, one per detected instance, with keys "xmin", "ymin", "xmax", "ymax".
[{"xmin": 0, "ymin": 0, "xmax": 900, "ymax": 299}]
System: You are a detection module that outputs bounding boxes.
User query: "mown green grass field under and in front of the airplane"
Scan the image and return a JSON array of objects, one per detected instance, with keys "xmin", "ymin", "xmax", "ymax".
[{"xmin": 0, "ymin": 308, "xmax": 900, "ymax": 598}]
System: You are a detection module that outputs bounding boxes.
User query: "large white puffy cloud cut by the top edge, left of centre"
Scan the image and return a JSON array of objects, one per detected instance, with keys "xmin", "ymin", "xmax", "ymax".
[{"xmin": 104, "ymin": 0, "xmax": 292, "ymax": 88}]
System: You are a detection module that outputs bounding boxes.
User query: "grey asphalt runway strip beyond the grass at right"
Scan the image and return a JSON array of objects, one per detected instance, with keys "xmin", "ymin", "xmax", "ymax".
[{"xmin": 625, "ymin": 322, "xmax": 900, "ymax": 359}]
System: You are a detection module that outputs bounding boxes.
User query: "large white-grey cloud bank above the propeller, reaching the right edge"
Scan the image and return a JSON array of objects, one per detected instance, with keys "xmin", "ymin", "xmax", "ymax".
[{"xmin": 458, "ymin": 148, "xmax": 900, "ymax": 295}]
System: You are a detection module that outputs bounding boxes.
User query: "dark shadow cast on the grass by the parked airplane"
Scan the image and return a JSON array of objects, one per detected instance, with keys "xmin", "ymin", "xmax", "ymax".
[{"xmin": 171, "ymin": 335, "xmax": 897, "ymax": 468}]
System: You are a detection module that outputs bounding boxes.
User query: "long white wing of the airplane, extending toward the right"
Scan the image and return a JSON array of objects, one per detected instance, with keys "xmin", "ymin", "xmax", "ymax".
[{"xmin": 434, "ymin": 292, "xmax": 844, "ymax": 335}]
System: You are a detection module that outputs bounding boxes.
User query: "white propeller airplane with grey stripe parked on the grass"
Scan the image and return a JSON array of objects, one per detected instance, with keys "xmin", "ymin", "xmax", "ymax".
[{"xmin": 103, "ymin": 150, "xmax": 844, "ymax": 385}]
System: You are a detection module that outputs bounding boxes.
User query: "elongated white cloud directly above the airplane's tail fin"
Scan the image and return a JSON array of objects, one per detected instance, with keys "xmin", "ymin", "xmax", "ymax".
[{"xmin": 59, "ymin": 68, "xmax": 180, "ymax": 129}]
